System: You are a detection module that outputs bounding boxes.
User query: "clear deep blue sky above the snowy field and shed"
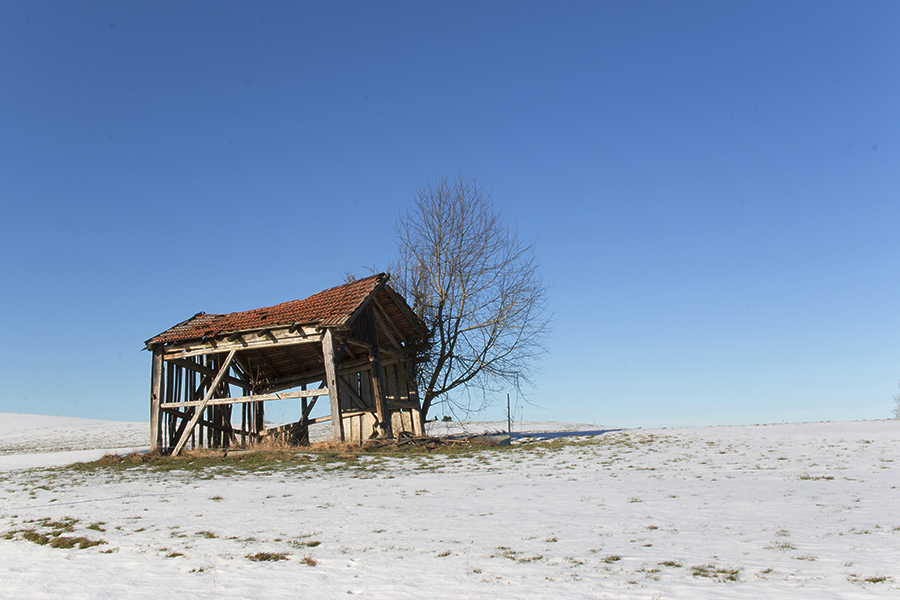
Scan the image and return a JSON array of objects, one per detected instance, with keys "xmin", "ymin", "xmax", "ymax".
[{"xmin": 0, "ymin": 0, "xmax": 900, "ymax": 426}]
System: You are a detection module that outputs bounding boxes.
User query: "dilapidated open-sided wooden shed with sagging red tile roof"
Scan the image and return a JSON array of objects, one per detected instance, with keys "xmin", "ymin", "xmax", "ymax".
[{"xmin": 145, "ymin": 273, "xmax": 425, "ymax": 455}]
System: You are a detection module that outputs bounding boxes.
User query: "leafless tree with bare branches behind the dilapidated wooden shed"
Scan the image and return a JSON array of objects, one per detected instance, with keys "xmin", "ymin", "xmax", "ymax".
[{"xmin": 391, "ymin": 175, "xmax": 550, "ymax": 418}]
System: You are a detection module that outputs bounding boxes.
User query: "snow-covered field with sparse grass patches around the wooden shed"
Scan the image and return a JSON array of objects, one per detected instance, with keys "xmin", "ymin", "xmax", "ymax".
[{"xmin": 0, "ymin": 414, "xmax": 900, "ymax": 600}]
